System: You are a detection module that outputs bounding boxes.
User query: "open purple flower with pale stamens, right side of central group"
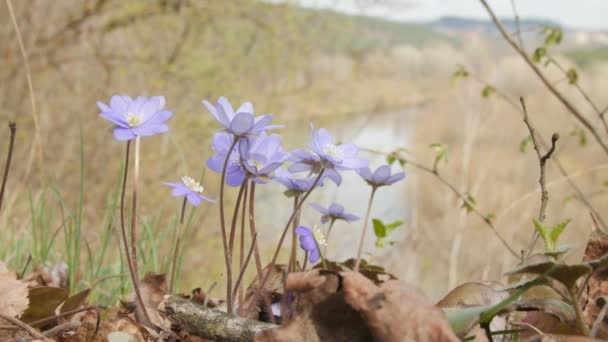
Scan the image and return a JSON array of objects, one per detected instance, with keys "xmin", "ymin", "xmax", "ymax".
[{"xmin": 289, "ymin": 124, "xmax": 368, "ymax": 185}]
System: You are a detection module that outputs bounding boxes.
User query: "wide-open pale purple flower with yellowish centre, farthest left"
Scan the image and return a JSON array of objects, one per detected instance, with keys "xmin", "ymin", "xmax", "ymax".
[{"xmin": 97, "ymin": 95, "xmax": 173, "ymax": 140}]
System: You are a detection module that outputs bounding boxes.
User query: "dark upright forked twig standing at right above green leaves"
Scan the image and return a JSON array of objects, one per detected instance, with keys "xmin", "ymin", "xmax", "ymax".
[{"xmin": 519, "ymin": 97, "xmax": 559, "ymax": 258}]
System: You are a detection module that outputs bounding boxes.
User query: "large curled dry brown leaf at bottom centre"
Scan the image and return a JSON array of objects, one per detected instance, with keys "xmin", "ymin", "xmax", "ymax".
[{"xmin": 255, "ymin": 271, "xmax": 458, "ymax": 342}]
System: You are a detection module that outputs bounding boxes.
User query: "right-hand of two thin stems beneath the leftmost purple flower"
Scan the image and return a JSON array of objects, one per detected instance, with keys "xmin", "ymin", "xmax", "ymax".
[{"xmin": 131, "ymin": 137, "xmax": 152, "ymax": 326}]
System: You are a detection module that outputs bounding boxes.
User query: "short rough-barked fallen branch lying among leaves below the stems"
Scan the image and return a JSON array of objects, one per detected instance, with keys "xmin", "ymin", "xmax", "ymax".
[{"xmin": 164, "ymin": 296, "xmax": 278, "ymax": 342}]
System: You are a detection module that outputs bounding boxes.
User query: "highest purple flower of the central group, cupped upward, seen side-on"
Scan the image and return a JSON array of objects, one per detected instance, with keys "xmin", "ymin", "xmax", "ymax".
[{"xmin": 203, "ymin": 96, "xmax": 283, "ymax": 137}]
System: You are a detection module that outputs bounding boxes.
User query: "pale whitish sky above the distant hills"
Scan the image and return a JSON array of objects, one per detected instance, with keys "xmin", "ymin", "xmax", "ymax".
[{"xmin": 299, "ymin": 0, "xmax": 608, "ymax": 31}]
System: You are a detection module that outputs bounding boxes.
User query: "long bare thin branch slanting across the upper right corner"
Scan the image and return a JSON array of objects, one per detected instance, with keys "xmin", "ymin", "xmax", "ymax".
[{"xmin": 479, "ymin": 0, "xmax": 608, "ymax": 154}]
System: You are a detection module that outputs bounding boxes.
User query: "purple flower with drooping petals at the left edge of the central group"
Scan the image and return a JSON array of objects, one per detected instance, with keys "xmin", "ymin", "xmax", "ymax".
[{"xmin": 207, "ymin": 132, "xmax": 245, "ymax": 186}]
